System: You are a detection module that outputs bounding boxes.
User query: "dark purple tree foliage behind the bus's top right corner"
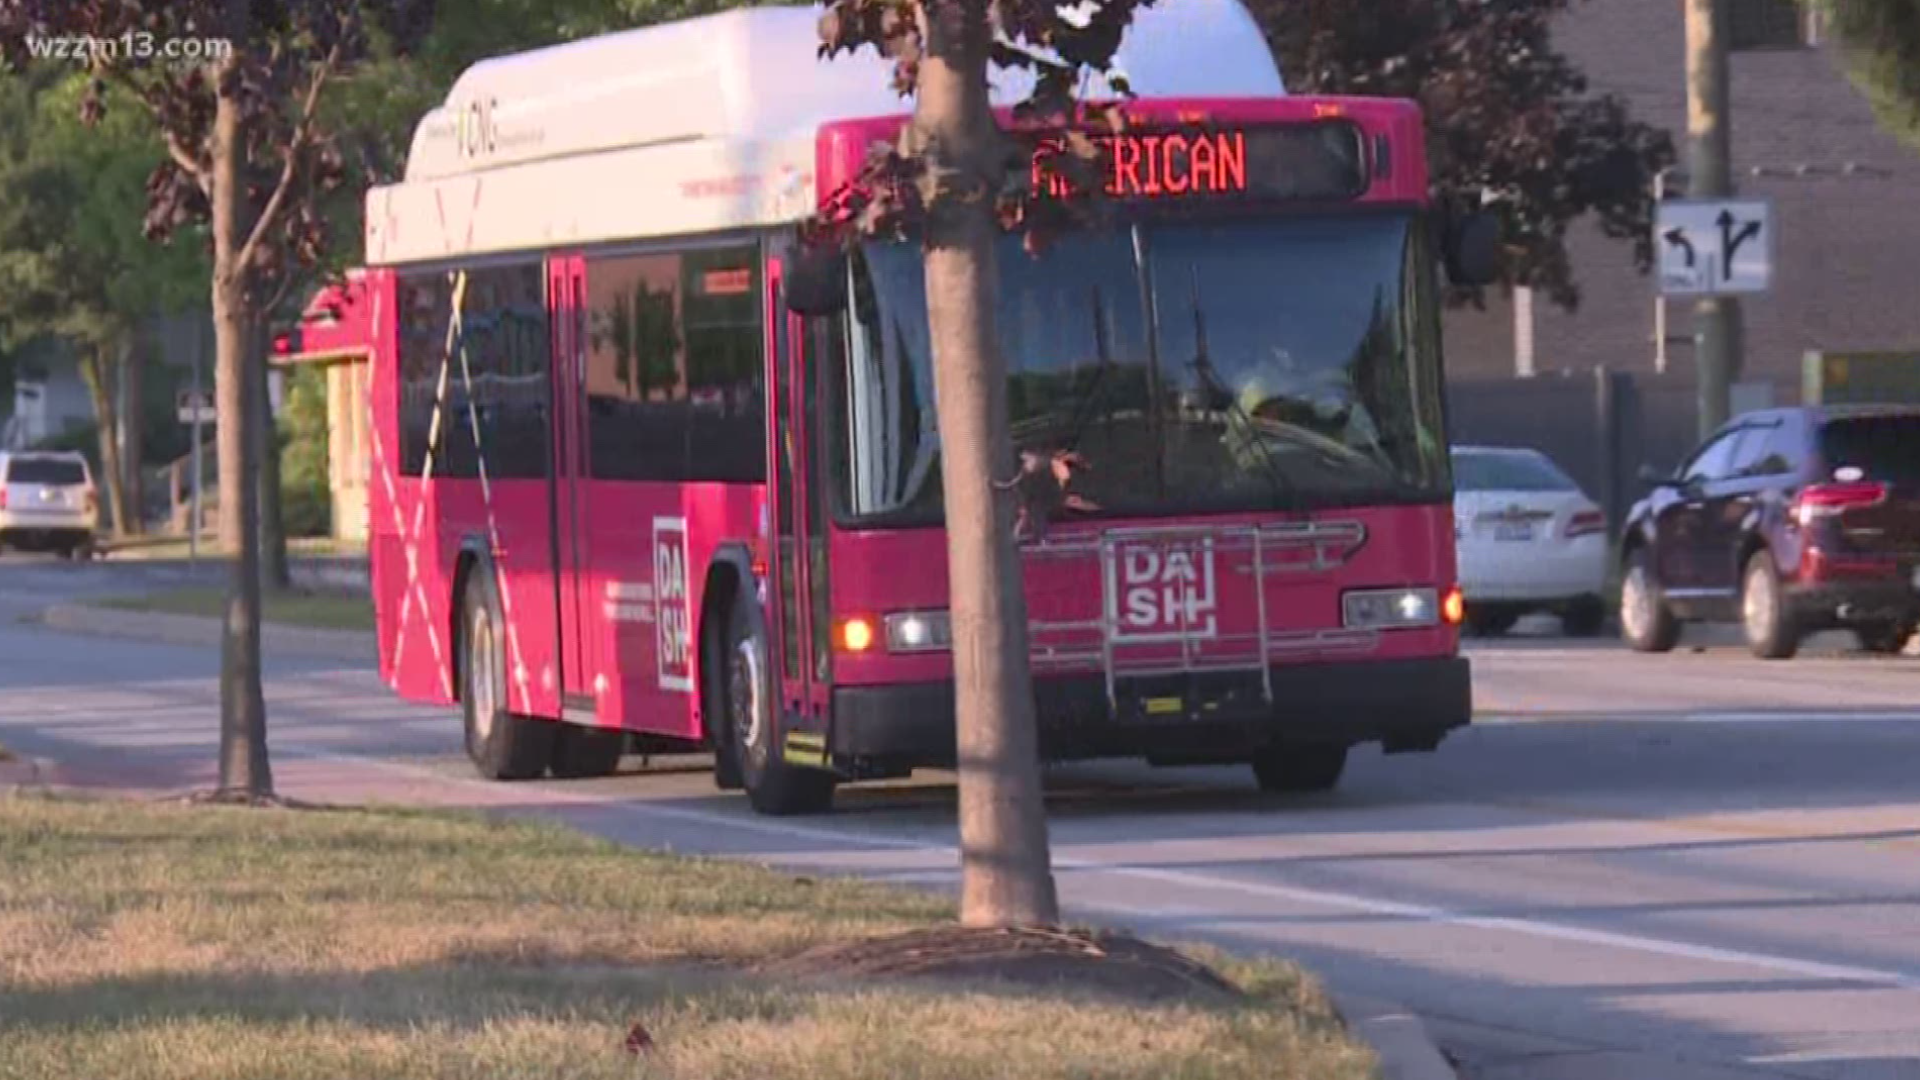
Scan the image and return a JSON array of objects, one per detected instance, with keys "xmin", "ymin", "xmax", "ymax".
[{"xmin": 1248, "ymin": 0, "xmax": 1674, "ymax": 307}]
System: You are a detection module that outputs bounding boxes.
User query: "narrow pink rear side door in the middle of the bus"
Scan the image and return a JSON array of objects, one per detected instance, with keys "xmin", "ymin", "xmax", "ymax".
[{"xmin": 547, "ymin": 256, "xmax": 601, "ymax": 719}]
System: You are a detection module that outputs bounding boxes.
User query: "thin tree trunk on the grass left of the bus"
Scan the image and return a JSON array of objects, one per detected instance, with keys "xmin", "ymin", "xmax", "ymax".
[{"xmin": 211, "ymin": 62, "xmax": 273, "ymax": 798}]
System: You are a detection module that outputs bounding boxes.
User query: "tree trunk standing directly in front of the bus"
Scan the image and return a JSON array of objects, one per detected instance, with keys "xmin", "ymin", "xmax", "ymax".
[{"xmin": 914, "ymin": 0, "xmax": 1060, "ymax": 926}]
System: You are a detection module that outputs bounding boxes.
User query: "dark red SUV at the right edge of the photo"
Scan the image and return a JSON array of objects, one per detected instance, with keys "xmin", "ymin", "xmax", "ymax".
[{"xmin": 1620, "ymin": 405, "xmax": 1920, "ymax": 659}]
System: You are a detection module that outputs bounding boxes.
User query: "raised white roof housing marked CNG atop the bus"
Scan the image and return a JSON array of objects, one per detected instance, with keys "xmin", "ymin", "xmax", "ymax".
[{"xmin": 405, "ymin": 0, "xmax": 1286, "ymax": 181}]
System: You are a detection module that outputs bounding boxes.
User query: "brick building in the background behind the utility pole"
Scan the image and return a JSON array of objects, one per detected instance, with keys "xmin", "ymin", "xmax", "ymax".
[{"xmin": 1448, "ymin": 0, "xmax": 1920, "ymax": 386}]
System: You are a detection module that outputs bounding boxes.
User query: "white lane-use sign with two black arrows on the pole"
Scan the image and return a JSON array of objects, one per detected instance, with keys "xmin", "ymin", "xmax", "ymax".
[{"xmin": 1653, "ymin": 198, "xmax": 1774, "ymax": 296}]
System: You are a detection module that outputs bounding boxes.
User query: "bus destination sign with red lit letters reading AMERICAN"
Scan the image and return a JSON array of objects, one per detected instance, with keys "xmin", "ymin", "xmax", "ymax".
[{"xmin": 1033, "ymin": 121, "xmax": 1367, "ymax": 202}]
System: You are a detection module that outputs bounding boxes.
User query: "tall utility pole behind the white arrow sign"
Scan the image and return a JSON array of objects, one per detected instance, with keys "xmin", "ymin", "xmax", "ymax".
[{"xmin": 1686, "ymin": 0, "xmax": 1741, "ymax": 438}]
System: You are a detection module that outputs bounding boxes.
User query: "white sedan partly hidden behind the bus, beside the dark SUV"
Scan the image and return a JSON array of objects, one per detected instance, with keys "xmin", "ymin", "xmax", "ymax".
[{"xmin": 1453, "ymin": 446, "xmax": 1607, "ymax": 636}]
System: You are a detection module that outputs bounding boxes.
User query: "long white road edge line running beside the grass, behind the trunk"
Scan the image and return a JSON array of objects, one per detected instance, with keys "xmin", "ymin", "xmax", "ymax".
[{"xmin": 278, "ymin": 744, "xmax": 1920, "ymax": 992}]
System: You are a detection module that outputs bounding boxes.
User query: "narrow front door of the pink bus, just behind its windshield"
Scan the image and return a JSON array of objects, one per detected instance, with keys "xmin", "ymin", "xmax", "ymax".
[{"xmin": 766, "ymin": 259, "xmax": 828, "ymax": 730}]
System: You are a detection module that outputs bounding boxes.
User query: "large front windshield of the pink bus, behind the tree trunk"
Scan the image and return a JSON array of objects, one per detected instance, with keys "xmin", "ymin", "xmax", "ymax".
[{"xmin": 826, "ymin": 213, "xmax": 1450, "ymax": 525}]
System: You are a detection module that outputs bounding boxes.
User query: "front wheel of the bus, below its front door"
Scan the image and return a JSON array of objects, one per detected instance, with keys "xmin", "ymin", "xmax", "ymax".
[{"xmin": 722, "ymin": 598, "xmax": 835, "ymax": 817}]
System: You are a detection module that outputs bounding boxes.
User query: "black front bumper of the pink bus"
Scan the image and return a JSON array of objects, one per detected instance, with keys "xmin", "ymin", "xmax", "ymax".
[{"xmin": 829, "ymin": 657, "xmax": 1473, "ymax": 771}]
